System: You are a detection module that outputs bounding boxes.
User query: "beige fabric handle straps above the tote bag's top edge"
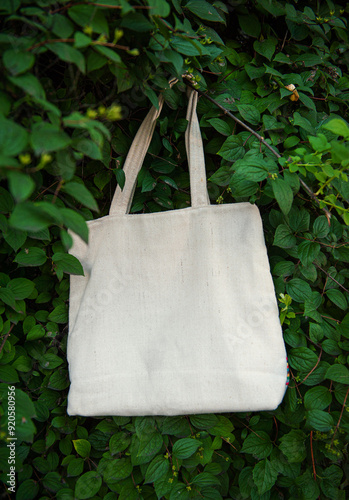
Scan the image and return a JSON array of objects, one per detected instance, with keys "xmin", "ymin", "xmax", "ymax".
[{"xmin": 109, "ymin": 79, "xmax": 210, "ymax": 215}]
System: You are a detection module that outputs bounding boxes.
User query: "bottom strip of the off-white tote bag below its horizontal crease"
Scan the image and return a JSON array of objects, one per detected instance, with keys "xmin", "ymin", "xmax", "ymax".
[{"xmin": 67, "ymin": 368, "xmax": 286, "ymax": 416}]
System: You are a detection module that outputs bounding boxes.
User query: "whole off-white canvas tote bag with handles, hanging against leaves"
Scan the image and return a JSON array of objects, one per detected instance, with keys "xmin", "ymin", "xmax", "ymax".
[{"xmin": 67, "ymin": 82, "xmax": 287, "ymax": 416}]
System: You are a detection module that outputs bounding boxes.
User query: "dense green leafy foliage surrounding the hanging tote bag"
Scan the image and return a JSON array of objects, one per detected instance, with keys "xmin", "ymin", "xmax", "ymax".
[{"xmin": 0, "ymin": 0, "xmax": 349, "ymax": 500}]
